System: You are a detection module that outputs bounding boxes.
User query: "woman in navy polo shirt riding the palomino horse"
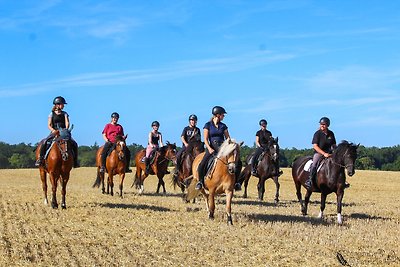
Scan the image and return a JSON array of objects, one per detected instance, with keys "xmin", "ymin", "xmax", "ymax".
[{"xmin": 196, "ymin": 106, "xmax": 240, "ymax": 190}]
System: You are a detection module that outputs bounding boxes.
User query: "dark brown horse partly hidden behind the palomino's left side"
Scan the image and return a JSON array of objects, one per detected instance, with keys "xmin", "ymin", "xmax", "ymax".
[{"xmin": 172, "ymin": 141, "xmax": 204, "ymax": 193}]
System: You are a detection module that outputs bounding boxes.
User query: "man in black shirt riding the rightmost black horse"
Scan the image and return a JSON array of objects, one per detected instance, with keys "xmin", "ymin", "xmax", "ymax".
[{"xmin": 305, "ymin": 117, "xmax": 336, "ymax": 190}]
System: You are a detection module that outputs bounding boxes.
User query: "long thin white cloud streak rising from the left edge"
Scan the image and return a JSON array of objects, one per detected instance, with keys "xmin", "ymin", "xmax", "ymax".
[{"xmin": 0, "ymin": 51, "xmax": 296, "ymax": 97}]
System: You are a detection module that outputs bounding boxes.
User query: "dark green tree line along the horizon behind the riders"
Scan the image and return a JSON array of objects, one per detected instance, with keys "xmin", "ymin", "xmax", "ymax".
[{"xmin": 0, "ymin": 142, "xmax": 400, "ymax": 171}]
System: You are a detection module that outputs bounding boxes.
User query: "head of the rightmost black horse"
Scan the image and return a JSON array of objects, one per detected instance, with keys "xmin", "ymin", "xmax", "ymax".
[{"xmin": 332, "ymin": 141, "xmax": 360, "ymax": 176}]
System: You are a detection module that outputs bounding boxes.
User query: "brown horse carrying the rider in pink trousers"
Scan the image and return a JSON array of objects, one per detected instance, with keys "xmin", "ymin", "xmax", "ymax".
[{"xmin": 132, "ymin": 142, "xmax": 176, "ymax": 197}]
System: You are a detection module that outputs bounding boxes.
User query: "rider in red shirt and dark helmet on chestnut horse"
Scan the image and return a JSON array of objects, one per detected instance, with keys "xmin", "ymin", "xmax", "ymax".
[{"xmin": 100, "ymin": 112, "xmax": 132, "ymax": 172}]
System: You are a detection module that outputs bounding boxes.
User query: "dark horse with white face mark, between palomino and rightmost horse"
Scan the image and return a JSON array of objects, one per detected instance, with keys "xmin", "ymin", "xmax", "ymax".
[{"xmin": 238, "ymin": 137, "xmax": 280, "ymax": 203}]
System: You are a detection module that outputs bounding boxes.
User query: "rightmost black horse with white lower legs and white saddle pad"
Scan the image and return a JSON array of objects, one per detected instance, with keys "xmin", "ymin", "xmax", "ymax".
[{"xmin": 292, "ymin": 141, "xmax": 359, "ymax": 224}]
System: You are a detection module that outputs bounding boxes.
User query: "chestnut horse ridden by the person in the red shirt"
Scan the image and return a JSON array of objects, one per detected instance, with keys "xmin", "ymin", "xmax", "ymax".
[{"xmin": 93, "ymin": 135, "xmax": 127, "ymax": 198}]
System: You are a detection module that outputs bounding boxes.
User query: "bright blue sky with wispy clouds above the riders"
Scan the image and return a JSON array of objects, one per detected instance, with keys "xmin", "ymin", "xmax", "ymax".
[{"xmin": 0, "ymin": 0, "xmax": 400, "ymax": 149}]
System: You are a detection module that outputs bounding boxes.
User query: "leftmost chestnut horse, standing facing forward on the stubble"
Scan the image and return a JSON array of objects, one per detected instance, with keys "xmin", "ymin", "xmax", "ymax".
[{"xmin": 36, "ymin": 129, "xmax": 74, "ymax": 209}]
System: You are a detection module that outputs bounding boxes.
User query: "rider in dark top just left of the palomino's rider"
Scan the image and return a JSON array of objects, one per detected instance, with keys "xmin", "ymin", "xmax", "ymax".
[{"xmin": 174, "ymin": 114, "xmax": 201, "ymax": 180}]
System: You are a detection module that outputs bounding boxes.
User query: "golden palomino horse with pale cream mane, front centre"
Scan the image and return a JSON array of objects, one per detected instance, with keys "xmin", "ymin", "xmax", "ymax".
[{"xmin": 186, "ymin": 138, "xmax": 243, "ymax": 225}]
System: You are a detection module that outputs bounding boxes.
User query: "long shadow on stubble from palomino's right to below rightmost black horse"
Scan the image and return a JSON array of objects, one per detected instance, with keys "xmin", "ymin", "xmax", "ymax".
[{"xmin": 244, "ymin": 214, "xmax": 331, "ymax": 226}]
